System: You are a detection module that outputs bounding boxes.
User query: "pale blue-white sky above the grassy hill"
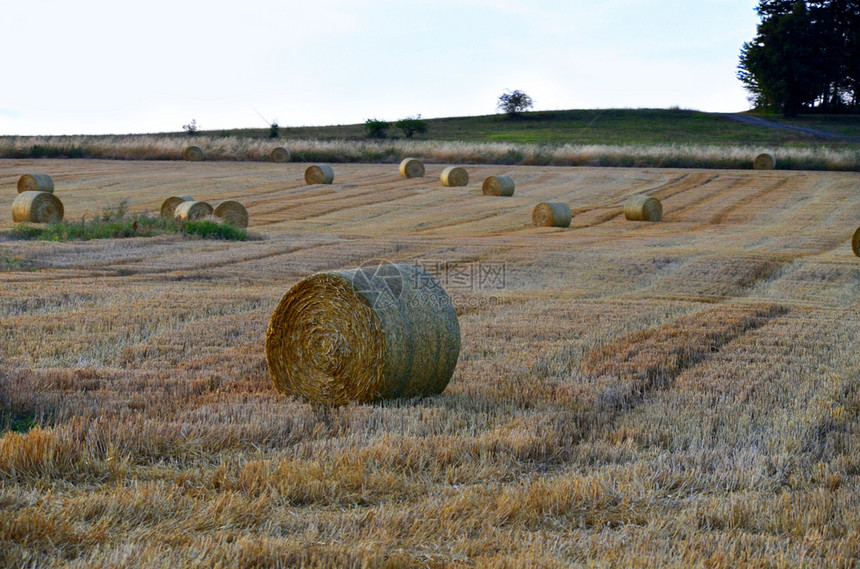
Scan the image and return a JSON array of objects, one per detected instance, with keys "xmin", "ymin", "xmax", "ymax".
[{"xmin": 0, "ymin": 0, "xmax": 758, "ymax": 135}]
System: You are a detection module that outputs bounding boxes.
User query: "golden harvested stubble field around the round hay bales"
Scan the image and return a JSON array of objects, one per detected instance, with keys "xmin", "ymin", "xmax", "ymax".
[{"xmin": 0, "ymin": 159, "xmax": 860, "ymax": 568}]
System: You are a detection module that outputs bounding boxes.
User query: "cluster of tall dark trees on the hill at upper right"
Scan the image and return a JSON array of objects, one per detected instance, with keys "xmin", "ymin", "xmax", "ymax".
[{"xmin": 738, "ymin": 0, "xmax": 860, "ymax": 116}]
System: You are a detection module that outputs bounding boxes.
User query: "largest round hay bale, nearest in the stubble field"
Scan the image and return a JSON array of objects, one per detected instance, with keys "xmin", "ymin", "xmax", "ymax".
[{"xmin": 266, "ymin": 263, "xmax": 460, "ymax": 405}]
